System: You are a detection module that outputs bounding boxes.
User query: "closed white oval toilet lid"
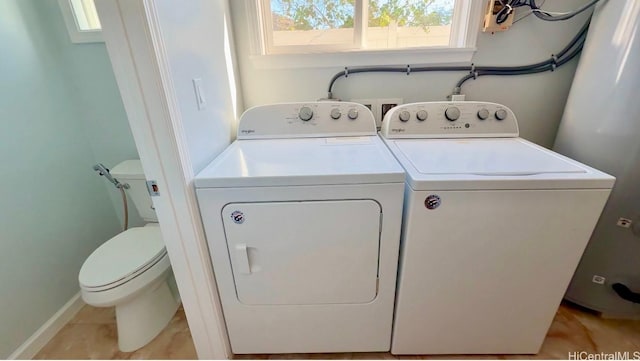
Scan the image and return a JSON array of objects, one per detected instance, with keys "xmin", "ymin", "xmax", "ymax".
[{"xmin": 78, "ymin": 227, "xmax": 166, "ymax": 287}]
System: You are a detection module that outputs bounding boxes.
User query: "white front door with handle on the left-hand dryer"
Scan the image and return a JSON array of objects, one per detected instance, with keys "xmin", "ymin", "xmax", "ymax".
[{"xmin": 222, "ymin": 200, "xmax": 381, "ymax": 305}]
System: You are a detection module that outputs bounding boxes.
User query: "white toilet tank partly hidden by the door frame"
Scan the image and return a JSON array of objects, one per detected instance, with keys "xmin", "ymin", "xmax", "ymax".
[{"xmin": 111, "ymin": 159, "xmax": 158, "ymax": 222}]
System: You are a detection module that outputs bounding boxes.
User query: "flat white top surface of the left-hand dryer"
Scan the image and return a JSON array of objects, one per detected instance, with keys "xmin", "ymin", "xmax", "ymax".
[{"xmin": 195, "ymin": 136, "xmax": 404, "ymax": 188}]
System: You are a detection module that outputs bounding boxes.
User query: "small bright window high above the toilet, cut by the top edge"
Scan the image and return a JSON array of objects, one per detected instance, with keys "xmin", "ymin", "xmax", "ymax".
[{"xmin": 58, "ymin": 0, "xmax": 103, "ymax": 43}]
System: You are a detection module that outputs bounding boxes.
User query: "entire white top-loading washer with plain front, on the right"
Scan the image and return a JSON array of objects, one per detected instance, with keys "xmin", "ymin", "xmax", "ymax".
[{"xmin": 382, "ymin": 102, "xmax": 615, "ymax": 354}]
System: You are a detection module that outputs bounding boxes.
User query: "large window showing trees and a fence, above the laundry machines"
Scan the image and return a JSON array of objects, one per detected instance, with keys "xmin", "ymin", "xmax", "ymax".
[{"xmin": 249, "ymin": 0, "xmax": 483, "ymax": 65}]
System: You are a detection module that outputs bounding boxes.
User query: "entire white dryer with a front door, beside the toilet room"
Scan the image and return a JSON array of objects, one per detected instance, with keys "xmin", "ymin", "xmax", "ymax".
[{"xmin": 195, "ymin": 102, "xmax": 404, "ymax": 354}]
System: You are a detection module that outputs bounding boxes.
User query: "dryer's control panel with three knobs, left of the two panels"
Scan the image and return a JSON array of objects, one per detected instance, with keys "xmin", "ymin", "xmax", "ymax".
[{"xmin": 238, "ymin": 101, "xmax": 376, "ymax": 139}]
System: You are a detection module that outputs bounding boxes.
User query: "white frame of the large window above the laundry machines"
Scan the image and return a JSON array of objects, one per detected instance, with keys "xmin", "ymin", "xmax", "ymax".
[{"xmin": 245, "ymin": 0, "xmax": 485, "ymax": 69}]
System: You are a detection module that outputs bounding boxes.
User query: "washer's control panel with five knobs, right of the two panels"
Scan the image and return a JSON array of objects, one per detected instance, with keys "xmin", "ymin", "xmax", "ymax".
[{"xmin": 381, "ymin": 101, "xmax": 518, "ymax": 138}]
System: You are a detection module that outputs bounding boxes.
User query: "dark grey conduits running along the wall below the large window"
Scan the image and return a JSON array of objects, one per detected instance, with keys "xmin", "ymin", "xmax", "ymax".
[{"xmin": 327, "ymin": 13, "xmax": 593, "ymax": 99}]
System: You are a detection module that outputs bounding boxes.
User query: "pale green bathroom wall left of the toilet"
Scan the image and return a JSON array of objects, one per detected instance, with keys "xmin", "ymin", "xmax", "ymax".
[{"xmin": 0, "ymin": 0, "xmax": 128, "ymax": 358}]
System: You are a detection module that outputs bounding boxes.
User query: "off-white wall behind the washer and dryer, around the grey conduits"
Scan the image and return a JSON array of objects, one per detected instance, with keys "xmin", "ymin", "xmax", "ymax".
[{"xmin": 231, "ymin": 0, "xmax": 587, "ymax": 147}]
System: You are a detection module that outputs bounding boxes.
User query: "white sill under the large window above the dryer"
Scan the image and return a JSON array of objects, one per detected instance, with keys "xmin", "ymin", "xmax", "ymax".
[{"xmin": 250, "ymin": 48, "xmax": 476, "ymax": 69}]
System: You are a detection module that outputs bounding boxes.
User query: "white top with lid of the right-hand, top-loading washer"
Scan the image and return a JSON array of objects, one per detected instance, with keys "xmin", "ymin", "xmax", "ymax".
[{"xmin": 386, "ymin": 138, "xmax": 615, "ymax": 190}]
